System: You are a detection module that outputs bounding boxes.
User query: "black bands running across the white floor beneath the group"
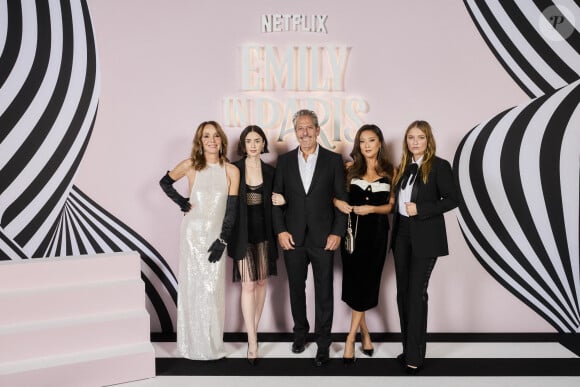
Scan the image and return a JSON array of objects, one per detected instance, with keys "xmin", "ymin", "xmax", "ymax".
[{"xmin": 153, "ymin": 333, "xmax": 580, "ymax": 378}]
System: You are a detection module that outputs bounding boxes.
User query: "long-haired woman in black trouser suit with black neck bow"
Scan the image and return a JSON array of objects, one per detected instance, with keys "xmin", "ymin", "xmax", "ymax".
[{"xmin": 391, "ymin": 121, "xmax": 458, "ymax": 374}]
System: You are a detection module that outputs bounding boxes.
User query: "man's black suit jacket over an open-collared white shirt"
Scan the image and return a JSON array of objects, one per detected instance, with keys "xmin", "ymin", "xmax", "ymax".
[{"xmin": 272, "ymin": 145, "xmax": 348, "ymax": 248}]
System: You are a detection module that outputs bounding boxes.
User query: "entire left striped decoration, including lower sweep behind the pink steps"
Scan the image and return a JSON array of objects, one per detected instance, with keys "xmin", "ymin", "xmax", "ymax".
[{"xmin": 0, "ymin": 0, "xmax": 177, "ymax": 333}]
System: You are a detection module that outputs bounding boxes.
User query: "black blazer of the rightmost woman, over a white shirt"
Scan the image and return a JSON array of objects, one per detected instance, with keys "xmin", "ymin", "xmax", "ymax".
[{"xmin": 391, "ymin": 157, "xmax": 458, "ymax": 257}]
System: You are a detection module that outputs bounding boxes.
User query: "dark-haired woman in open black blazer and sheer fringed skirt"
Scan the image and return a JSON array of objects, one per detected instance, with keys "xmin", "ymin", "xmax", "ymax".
[{"xmin": 228, "ymin": 125, "xmax": 284, "ymax": 365}]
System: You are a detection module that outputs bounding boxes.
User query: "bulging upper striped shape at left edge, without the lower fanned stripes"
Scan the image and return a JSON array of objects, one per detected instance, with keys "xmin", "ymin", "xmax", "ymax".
[{"xmin": 0, "ymin": 1, "xmax": 99, "ymax": 256}]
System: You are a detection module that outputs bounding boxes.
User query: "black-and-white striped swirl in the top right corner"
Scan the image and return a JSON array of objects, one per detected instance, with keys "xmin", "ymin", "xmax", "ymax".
[{"xmin": 464, "ymin": 0, "xmax": 580, "ymax": 97}]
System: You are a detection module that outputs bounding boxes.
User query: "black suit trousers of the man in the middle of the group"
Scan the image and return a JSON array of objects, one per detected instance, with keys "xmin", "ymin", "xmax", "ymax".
[{"xmin": 284, "ymin": 247, "xmax": 334, "ymax": 351}]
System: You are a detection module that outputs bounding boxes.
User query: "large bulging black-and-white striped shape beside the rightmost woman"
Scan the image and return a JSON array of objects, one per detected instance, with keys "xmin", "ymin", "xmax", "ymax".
[{"xmin": 454, "ymin": 81, "xmax": 580, "ymax": 332}]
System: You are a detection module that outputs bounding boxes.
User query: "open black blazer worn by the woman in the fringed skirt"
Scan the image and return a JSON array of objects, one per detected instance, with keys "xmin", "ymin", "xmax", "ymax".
[{"xmin": 228, "ymin": 158, "xmax": 278, "ymax": 261}]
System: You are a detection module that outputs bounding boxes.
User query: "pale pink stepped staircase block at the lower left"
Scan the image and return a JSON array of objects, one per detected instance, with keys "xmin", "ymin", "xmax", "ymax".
[{"xmin": 0, "ymin": 252, "xmax": 155, "ymax": 387}]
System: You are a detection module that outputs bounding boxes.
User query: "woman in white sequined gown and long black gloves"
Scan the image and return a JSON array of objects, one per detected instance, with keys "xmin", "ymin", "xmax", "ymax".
[{"xmin": 160, "ymin": 121, "xmax": 240, "ymax": 360}]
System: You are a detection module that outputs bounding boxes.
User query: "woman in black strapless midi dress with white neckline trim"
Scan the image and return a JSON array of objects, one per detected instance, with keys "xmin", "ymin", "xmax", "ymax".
[{"xmin": 334, "ymin": 125, "xmax": 395, "ymax": 364}]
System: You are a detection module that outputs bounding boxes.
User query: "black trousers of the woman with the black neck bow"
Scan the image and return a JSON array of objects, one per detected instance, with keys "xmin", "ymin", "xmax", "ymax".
[{"xmin": 393, "ymin": 216, "xmax": 437, "ymax": 367}]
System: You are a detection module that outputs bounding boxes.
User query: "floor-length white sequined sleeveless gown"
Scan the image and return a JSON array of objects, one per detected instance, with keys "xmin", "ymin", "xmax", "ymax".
[{"xmin": 177, "ymin": 164, "xmax": 228, "ymax": 360}]
